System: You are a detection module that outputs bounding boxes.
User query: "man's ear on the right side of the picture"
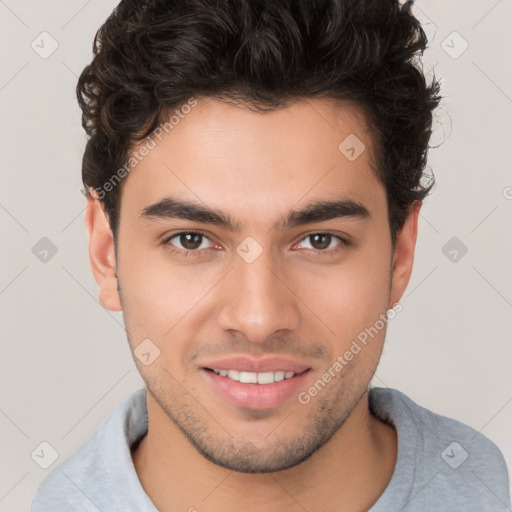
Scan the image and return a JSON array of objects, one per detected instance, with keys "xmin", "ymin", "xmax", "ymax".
[{"xmin": 389, "ymin": 201, "xmax": 421, "ymax": 308}]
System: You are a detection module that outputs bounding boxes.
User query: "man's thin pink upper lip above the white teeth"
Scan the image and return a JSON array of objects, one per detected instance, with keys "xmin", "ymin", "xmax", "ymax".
[{"xmin": 202, "ymin": 356, "xmax": 311, "ymax": 373}]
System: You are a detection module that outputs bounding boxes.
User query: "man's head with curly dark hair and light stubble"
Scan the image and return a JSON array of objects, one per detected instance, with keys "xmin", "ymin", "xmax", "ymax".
[{"xmin": 77, "ymin": 0, "xmax": 440, "ymax": 472}]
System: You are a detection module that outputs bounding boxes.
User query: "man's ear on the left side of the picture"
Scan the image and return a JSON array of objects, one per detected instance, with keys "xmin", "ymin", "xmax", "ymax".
[{"xmin": 85, "ymin": 197, "xmax": 121, "ymax": 311}]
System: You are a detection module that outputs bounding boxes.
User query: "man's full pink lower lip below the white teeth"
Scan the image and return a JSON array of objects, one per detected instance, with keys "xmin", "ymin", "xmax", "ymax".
[{"xmin": 201, "ymin": 368, "xmax": 310, "ymax": 409}]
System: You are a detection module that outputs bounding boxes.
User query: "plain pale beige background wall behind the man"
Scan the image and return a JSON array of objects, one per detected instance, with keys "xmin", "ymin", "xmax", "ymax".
[{"xmin": 0, "ymin": 0, "xmax": 512, "ymax": 512}]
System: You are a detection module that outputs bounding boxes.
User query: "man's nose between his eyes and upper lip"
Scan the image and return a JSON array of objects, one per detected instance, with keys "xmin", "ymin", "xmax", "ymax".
[{"xmin": 217, "ymin": 244, "xmax": 300, "ymax": 344}]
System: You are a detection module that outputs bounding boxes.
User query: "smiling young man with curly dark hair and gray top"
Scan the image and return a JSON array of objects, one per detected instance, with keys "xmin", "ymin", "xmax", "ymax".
[{"xmin": 33, "ymin": 0, "xmax": 509, "ymax": 512}]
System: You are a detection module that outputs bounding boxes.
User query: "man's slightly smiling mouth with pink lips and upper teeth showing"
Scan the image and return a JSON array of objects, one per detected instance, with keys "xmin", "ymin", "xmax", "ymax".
[{"xmin": 199, "ymin": 358, "xmax": 312, "ymax": 410}]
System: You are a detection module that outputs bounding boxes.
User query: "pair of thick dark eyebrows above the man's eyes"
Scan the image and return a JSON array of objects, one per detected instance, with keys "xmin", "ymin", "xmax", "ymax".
[{"xmin": 140, "ymin": 197, "xmax": 370, "ymax": 231}]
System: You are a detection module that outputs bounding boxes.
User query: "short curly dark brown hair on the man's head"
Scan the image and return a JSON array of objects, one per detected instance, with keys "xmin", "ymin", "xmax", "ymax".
[{"xmin": 77, "ymin": 0, "xmax": 441, "ymax": 244}]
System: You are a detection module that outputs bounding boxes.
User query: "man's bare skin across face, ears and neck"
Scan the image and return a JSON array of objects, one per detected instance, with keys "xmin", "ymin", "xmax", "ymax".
[{"xmin": 85, "ymin": 98, "xmax": 420, "ymax": 512}]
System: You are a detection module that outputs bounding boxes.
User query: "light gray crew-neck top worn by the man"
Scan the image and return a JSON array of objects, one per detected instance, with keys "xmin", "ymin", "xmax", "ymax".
[{"xmin": 32, "ymin": 388, "xmax": 510, "ymax": 512}]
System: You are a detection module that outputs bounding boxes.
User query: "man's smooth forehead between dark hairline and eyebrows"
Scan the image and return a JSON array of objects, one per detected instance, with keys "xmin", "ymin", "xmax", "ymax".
[{"xmin": 121, "ymin": 98, "xmax": 385, "ymax": 227}]
